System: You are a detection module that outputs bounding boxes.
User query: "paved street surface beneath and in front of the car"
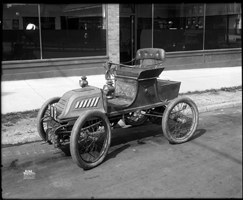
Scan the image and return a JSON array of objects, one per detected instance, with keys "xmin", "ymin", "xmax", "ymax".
[{"xmin": 2, "ymin": 107, "xmax": 242, "ymax": 199}]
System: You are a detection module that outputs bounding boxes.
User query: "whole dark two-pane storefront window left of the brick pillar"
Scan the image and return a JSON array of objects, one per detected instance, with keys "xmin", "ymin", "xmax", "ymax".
[{"xmin": 2, "ymin": 4, "xmax": 106, "ymax": 61}]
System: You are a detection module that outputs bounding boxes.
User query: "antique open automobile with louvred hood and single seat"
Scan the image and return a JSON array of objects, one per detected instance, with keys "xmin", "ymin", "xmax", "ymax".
[{"xmin": 37, "ymin": 48, "xmax": 199, "ymax": 170}]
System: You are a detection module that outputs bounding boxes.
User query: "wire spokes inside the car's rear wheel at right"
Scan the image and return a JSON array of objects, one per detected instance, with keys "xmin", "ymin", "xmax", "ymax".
[{"xmin": 168, "ymin": 102, "xmax": 195, "ymax": 138}]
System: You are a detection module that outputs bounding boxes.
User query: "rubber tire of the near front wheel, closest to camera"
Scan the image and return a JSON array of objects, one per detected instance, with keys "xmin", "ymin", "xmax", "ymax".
[{"xmin": 70, "ymin": 110, "xmax": 111, "ymax": 170}]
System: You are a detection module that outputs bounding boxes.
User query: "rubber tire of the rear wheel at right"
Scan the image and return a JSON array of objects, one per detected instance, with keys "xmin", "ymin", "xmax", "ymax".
[{"xmin": 162, "ymin": 97, "xmax": 199, "ymax": 144}]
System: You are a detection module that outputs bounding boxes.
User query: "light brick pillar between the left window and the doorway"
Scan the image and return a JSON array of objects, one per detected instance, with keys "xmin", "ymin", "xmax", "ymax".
[{"xmin": 107, "ymin": 4, "xmax": 120, "ymax": 63}]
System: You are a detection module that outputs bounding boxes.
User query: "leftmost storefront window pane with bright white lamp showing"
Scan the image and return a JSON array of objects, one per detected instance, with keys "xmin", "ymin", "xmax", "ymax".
[{"xmin": 2, "ymin": 4, "xmax": 40, "ymax": 61}]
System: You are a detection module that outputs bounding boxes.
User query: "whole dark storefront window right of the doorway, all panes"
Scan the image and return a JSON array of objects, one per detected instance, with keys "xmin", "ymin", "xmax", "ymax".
[{"xmin": 153, "ymin": 3, "xmax": 242, "ymax": 52}]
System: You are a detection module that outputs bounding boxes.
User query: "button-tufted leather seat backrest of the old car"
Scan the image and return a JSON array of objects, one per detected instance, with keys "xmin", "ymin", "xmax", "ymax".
[{"xmin": 136, "ymin": 48, "xmax": 165, "ymax": 68}]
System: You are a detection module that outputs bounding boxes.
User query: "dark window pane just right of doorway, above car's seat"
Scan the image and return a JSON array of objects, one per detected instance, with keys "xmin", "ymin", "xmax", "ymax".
[{"xmin": 153, "ymin": 3, "xmax": 204, "ymax": 52}]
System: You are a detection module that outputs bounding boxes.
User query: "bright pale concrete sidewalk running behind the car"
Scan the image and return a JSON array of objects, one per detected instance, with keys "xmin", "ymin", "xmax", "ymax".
[{"xmin": 1, "ymin": 66, "xmax": 242, "ymax": 114}]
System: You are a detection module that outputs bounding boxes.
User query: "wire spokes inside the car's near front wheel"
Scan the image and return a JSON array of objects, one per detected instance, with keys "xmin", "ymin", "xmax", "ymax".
[{"xmin": 78, "ymin": 117, "xmax": 107, "ymax": 163}]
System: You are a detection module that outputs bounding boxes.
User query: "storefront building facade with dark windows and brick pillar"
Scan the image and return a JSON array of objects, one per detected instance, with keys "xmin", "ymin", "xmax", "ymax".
[{"xmin": 1, "ymin": 3, "xmax": 242, "ymax": 80}]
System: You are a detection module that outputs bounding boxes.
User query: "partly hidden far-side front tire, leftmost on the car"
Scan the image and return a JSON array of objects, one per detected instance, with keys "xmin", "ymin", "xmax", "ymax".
[{"xmin": 37, "ymin": 97, "xmax": 61, "ymax": 141}]
